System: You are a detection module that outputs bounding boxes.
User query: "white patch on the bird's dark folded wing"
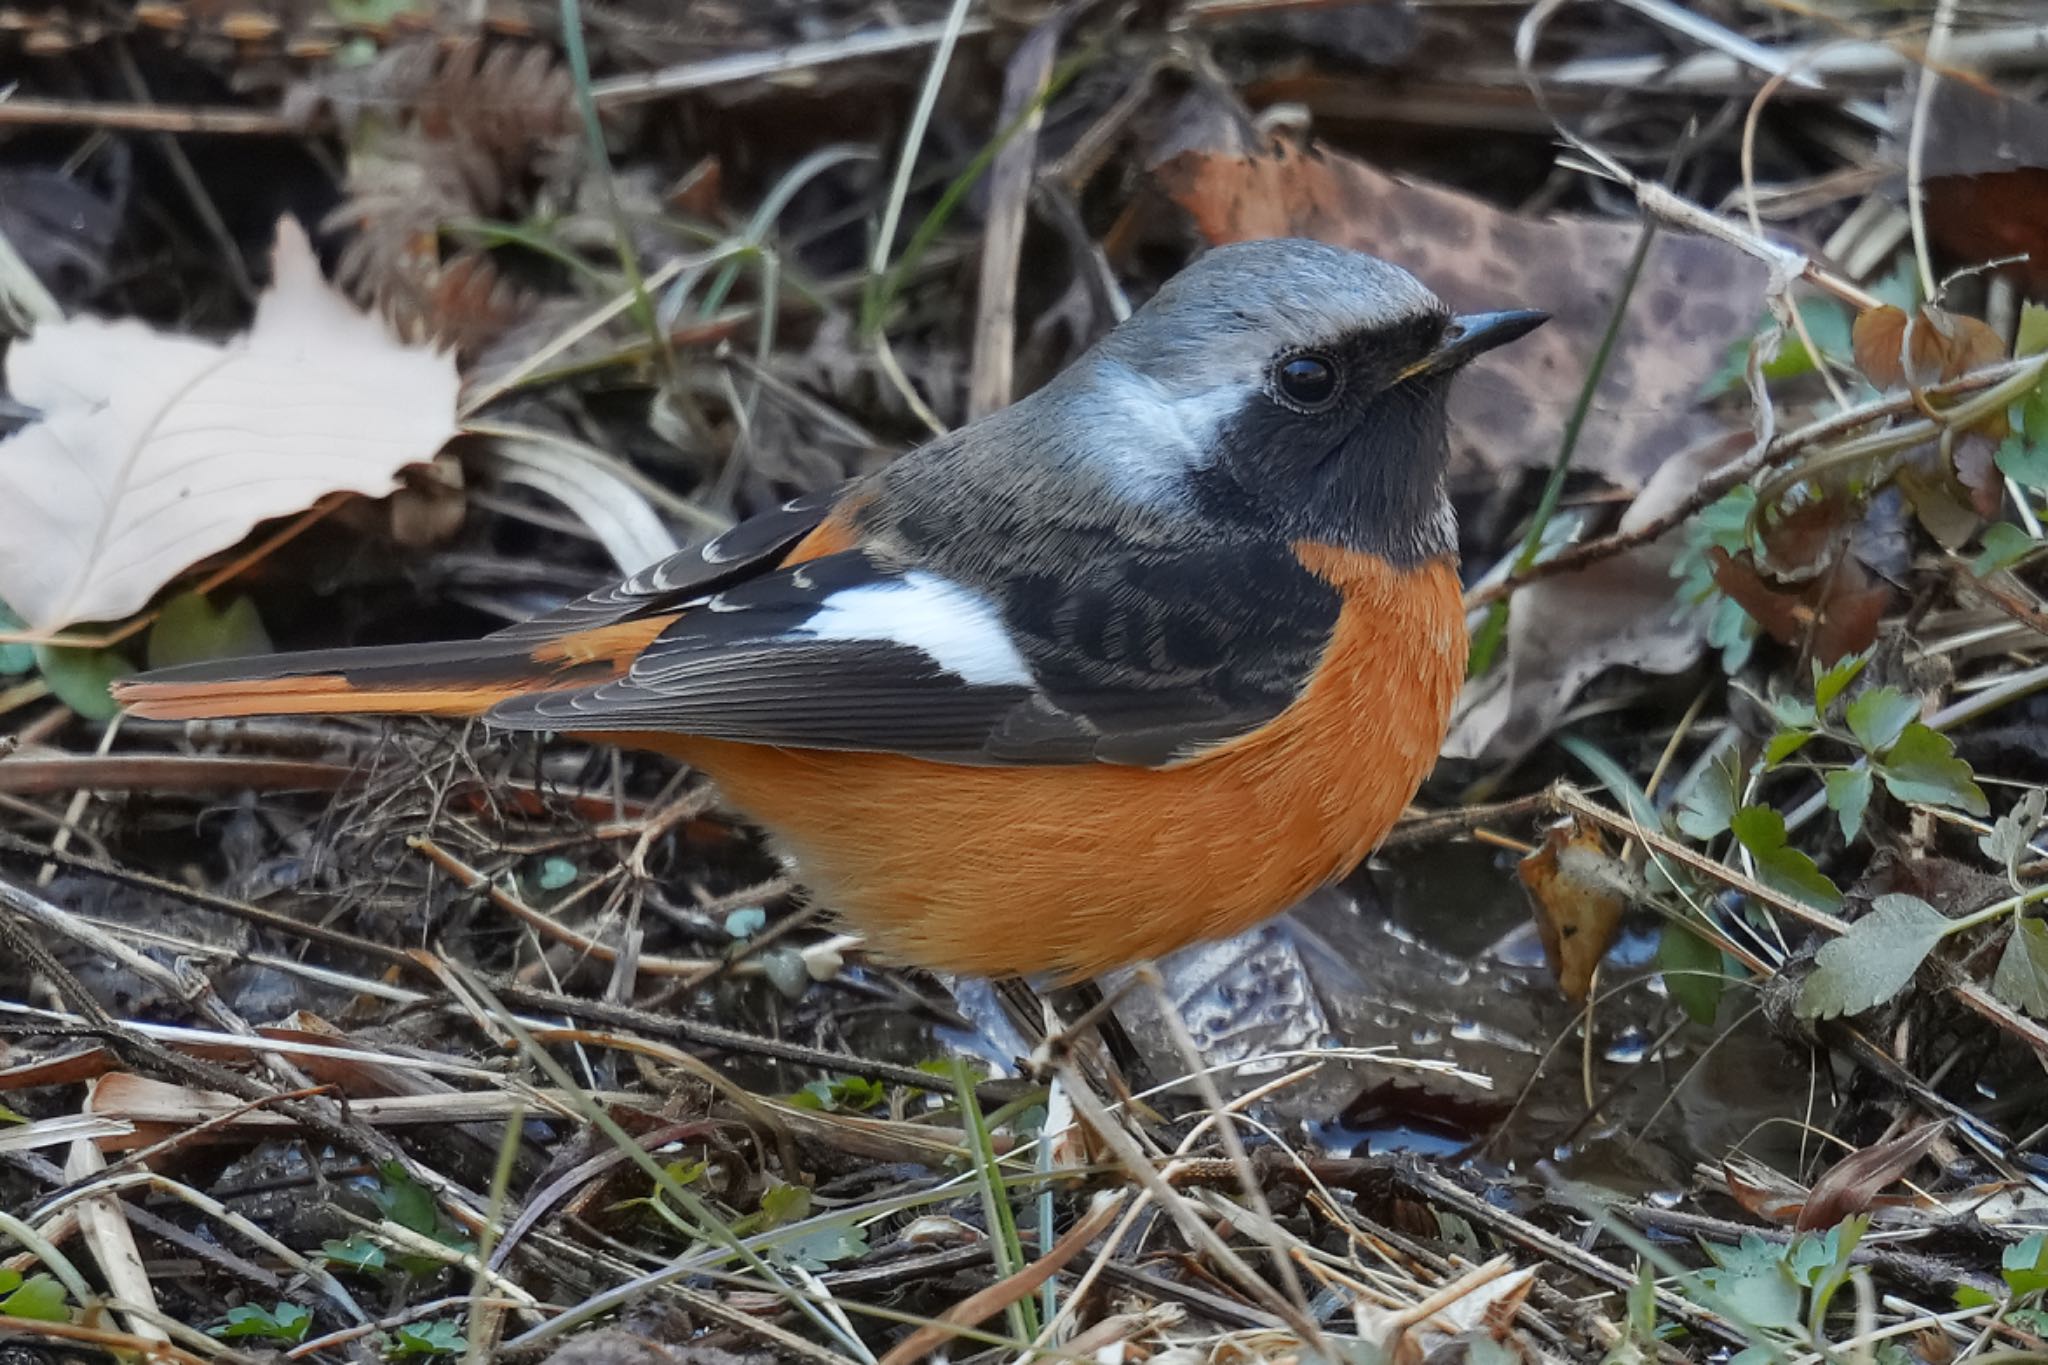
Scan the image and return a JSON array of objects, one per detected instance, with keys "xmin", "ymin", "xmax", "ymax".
[{"xmin": 793, "ymin": 569, "xmax": 1034, "ymax": 688}]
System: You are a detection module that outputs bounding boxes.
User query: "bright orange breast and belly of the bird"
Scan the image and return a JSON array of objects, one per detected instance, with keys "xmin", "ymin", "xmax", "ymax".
[{"xmin": 647, "ymin": 546, "xmax": 1464, "ymax": 976}]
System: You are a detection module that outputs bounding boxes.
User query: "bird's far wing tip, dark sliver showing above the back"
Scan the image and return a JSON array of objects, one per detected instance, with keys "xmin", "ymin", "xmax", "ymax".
[{"xmin": 492, "ymin": 485, "xmax": 846, "ymax": 641}]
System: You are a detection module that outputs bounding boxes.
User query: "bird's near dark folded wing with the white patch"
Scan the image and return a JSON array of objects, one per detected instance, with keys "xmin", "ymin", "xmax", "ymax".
[{"xmin": 489, "ymin": 544, "xmax": 1341, "ymax": 765}]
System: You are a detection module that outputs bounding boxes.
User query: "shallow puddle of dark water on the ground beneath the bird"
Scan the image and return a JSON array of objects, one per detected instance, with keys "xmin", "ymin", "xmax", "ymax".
[{"xmin": 1097, "ymin": 843, "xmax": 1827, "ymax": 1197}]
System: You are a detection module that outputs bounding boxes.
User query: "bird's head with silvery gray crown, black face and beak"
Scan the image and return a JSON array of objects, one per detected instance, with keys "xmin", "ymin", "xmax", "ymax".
[{"xmin": 1051, "ymin": 239, "xmax": 1544, "ymax": 567}]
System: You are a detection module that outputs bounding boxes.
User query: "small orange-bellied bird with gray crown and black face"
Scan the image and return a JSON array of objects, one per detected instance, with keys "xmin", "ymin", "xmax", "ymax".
[{"xmin": 117, "ymin": 237, "xmax": 1546, "ymax": 980}]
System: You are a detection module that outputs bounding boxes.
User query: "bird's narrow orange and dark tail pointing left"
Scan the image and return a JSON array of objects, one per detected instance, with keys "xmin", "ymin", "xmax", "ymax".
[{"xmin": 113, "ymin": 616, "xmax": 674, "ymax": 720}]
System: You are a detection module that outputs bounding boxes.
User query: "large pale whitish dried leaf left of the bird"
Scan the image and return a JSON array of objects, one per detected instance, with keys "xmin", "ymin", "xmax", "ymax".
[{"xmin": 0, "ymin": 217, "xmax": 459, "ymax": 630}]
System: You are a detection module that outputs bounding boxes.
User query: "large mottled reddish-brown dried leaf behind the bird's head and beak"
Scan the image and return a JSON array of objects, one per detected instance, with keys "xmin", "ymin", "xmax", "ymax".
[{"xmin": 1153, "ymin": 133, "xmax": 1765, "ymax": 489}]
